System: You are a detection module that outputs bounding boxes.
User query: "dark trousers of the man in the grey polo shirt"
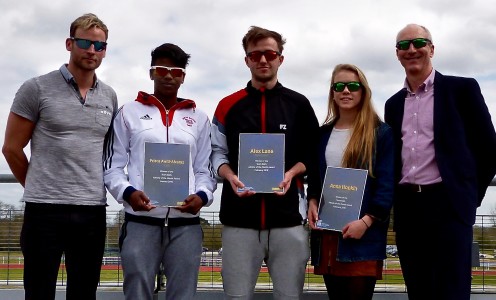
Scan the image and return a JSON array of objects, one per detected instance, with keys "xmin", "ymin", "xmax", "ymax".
[{"xmin": 21, "ymin": 202, "xmax": 106, "ymax": 300}]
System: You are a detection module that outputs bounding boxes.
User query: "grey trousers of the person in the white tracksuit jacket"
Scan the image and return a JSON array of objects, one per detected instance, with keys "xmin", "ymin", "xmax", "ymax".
[{"xmin": 121, "ymin": 222, "xmax": 202, "ymax": 300}]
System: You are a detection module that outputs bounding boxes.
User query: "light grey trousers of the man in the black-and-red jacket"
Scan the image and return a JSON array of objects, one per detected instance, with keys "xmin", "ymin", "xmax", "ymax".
[{"xmin": 222, "ymin": 225, "xmax": 310, "ymax": 300}]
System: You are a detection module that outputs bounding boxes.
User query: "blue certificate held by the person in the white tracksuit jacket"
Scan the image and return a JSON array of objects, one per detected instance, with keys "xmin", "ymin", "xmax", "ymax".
[{"xmin": 143, "ymin": 142, "xmax": 190, "ymax": 207}]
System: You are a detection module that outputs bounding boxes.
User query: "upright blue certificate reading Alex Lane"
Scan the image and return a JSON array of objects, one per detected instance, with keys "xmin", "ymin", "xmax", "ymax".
[{"xmin": 238, "ymin": 133, "xmax": 285, "ymax": 193}]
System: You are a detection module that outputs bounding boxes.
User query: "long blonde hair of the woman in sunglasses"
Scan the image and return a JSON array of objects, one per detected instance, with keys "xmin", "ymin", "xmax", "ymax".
[{"xmin": 324, "ymin": 64, "xmax": 380, "ymax": 177}]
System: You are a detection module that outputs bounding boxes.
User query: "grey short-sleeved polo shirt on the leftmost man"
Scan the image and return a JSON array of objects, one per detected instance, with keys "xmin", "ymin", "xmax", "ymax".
[{"xmin": 11, "ymin": 65, "xmax": 117, "ymax": 205}]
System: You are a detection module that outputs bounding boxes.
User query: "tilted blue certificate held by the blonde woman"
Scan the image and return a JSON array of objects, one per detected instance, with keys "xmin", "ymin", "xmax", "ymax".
[{"xmin": 316, "ymin": 167, "xmax": 368, "ymax": 231}]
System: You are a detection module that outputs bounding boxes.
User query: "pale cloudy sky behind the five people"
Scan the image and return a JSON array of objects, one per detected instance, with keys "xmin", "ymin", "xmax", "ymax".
[{"xmin": 0, "ymin": 0, "xmax": 496, "ymax": 214}]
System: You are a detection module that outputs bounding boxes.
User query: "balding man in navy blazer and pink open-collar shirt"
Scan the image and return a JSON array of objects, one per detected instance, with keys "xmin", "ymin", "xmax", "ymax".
[{"xmin": 385, "ymin": 24, "xmax": 496, "ymax": 300}]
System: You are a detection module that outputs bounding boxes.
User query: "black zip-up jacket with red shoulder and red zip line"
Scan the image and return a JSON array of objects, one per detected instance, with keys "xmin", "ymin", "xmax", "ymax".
[{"xmin": 212, "ymin": 82, "xmax": 321, "ymax": 229}]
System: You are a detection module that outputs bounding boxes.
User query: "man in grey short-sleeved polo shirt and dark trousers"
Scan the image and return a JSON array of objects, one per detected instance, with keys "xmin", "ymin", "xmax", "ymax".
[{"xmin": 2, "ymin": 14, "xmax": 117, "ymax": 300}]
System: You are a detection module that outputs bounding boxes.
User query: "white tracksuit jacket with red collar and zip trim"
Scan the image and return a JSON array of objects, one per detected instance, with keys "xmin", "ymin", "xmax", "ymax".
[{"xmin": 104, "ymin": 92, "xmax": 217, "ymax": 218}]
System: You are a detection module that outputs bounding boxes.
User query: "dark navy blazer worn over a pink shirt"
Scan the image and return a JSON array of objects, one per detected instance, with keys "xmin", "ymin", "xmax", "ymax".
[{"xmin": 384, "ymin": 71, "xmax": 496, "ymax": 225}]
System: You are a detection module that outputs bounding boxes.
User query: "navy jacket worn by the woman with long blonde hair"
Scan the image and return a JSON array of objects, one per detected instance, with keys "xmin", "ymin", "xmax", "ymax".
[{"xmin": 319, "ymin": 122, "xmax": 394, "ymax": 262}]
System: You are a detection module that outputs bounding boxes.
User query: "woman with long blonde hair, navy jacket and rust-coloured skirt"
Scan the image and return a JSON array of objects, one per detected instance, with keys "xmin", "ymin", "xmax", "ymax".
[{"xmin": 308, "ymin": 64, "xmax": 394, "ymax": 299}]
